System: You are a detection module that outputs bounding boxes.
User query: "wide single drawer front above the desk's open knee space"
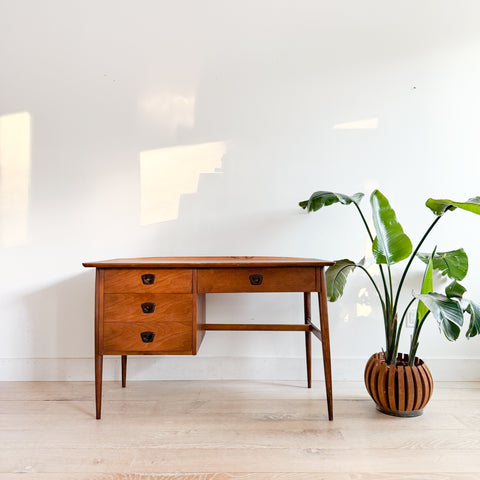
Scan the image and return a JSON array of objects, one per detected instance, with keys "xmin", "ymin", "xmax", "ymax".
[{"xmin": 198, "ymin": 267, "xmax": 315, "ymax": 293}]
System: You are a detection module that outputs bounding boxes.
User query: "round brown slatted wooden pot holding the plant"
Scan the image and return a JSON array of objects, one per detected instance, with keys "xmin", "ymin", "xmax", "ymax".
[{"xmin": 365, "ymin": 352, "xmax": 433, "ymax": 417}]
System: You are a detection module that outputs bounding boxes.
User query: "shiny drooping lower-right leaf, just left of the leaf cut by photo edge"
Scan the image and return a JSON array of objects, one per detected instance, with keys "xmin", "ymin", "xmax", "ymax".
[{"xmin": 417, "ymin": 293, "xmax": 463, "ymax": 341}]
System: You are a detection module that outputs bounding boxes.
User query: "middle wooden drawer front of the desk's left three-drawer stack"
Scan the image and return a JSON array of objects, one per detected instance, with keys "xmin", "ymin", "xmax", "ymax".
[{"xmin": 103, "ymin": 293, "xmax": 193, "ymax": 322}]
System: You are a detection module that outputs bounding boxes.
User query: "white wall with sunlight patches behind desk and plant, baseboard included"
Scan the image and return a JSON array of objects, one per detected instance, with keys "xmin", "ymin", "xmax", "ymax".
[{"xmin": 0, "ymin": 0, "xmax": 480, "ymax": 380}]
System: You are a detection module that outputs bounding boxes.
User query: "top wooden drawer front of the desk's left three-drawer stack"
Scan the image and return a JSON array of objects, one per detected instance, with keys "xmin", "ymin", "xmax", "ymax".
[{"xmin": 104, "ymin": 268, "xmax": 192, "ymax": 293}]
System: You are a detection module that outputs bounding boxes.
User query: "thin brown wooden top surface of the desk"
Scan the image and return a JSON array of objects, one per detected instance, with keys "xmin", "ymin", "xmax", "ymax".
[{"xmin": 83, "ymin": 256, "xmax": 335, "ymax": 268}]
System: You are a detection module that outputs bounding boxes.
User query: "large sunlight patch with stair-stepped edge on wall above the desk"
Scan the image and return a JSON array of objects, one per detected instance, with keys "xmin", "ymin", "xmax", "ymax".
[{"xmin": 140, "ymin": 142, "xmax": 226, "ymax": 225}]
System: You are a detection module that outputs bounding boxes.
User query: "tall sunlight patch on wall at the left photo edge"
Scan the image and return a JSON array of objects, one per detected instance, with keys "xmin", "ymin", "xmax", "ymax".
[{"xmin": 0, "ymin": 112, "xmax": 31, "ymax": 247}]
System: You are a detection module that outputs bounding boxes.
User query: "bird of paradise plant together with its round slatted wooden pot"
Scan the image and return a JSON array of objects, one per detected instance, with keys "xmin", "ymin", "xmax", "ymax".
[{"xmin": 299, "ymin": 190, "xmax": 480, "ymax": 416}]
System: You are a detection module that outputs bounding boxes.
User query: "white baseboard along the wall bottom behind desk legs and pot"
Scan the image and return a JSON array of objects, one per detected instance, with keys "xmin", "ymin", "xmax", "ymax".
[{"xmin": 0, "ymin": 355, "xmax": 480, "ymax": 381}]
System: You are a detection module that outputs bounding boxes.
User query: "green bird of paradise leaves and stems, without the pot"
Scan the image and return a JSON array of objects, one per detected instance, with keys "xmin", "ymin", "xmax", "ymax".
[{"xmin": 299, "ymin": 190, "xmax": 480, "ymax": 366}]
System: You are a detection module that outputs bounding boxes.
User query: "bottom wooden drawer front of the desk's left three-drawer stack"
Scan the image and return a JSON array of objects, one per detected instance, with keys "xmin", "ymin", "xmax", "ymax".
[{"xmin": 103, "ymin": 322, "xmax": 192, "ymax": 354}]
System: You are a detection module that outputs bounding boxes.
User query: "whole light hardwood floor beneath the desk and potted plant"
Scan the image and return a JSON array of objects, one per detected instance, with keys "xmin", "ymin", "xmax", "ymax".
[{"xmin": 0, "ymin": 381, "xmax": 480, "ymax": 480}]
